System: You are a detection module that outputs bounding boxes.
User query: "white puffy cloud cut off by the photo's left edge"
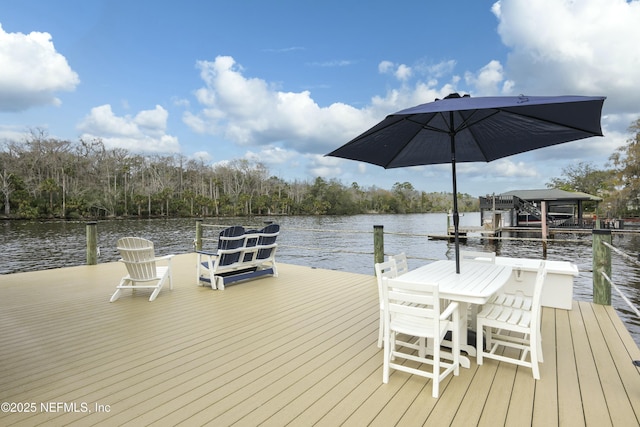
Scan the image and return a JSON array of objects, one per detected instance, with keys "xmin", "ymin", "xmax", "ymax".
[{"xmin": 0, "ymin": 25, "xmax": 80, "ymax": 111}]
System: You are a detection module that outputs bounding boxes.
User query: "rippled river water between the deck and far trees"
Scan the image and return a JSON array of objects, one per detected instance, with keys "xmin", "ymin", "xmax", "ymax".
[{"xmin": 0, "ymin": 213, "xmax": 640, "ymax": 345}]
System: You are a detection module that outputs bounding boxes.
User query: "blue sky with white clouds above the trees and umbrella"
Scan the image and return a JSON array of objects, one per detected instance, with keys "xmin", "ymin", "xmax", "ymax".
[{"xmin": 0, "ymin": 0, "xmax": 640, "ymax": 196}]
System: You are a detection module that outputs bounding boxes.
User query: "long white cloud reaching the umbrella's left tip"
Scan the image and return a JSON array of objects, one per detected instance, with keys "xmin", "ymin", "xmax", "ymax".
[{"xmin": 183, "ymin": 56, "xmax": 377, "ymax": 152}]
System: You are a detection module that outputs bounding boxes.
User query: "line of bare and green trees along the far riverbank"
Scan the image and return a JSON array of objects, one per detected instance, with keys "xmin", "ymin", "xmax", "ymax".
[{"xmin": 0, "ymin": 130, "xmax": 478, "ymax": 219}]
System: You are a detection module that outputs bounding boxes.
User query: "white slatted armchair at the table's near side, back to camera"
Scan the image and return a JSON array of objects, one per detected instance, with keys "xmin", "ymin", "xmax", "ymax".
[{"xmin": 382, "ymin": 277, "xmax": 460, "ymax": 398}]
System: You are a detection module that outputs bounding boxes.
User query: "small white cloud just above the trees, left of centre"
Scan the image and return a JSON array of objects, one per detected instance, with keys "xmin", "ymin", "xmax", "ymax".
[{"xmin": 78, "ymin": 104, "xmax": 180, "ymax": 153}]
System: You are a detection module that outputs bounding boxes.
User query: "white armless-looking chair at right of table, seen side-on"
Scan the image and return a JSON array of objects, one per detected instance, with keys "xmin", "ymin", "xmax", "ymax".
[{"xmin": 476, "ymin": 261, "xmax": 547, "ymax": 380}]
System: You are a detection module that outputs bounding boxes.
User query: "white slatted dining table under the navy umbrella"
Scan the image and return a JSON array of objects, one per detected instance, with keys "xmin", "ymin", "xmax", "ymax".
[{"xmin": 397, "ymin": 260, "xmax": 511, "ymax": 368}]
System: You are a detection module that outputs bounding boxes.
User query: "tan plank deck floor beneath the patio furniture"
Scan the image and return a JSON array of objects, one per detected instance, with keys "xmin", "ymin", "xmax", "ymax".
[{"xmin": 0, "ymin": 254, "xmax": 640, "ymax": 427}]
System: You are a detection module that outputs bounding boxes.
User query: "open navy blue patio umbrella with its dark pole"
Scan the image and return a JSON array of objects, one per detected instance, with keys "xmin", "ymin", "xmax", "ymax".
[{"xmin": 327, "ymin": 93, "xmax": 605, "ymax": 273}]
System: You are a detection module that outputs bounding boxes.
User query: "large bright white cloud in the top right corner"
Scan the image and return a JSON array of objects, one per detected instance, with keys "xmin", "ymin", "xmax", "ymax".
[{"xmin": 493, "ymin": 0, "xmax": 640, "ymax": 113}]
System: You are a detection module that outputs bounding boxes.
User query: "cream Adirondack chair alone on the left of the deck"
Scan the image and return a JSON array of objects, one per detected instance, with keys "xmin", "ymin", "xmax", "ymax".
[{"xmin": 110, "ymin": 237, "xmax": 174, "ymax": 302}]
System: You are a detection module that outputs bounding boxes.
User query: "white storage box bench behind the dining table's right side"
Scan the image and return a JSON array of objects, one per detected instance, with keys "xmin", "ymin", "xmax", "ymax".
[{"xmin": 496, "ymin": 257, "xmax": 579, "ymax": 310}]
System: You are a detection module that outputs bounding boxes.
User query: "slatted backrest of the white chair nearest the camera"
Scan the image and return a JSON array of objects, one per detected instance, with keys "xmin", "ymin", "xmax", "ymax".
[{"xmin": 382, "ymin": 277, "xmax": 440, "ymax": 331}]
